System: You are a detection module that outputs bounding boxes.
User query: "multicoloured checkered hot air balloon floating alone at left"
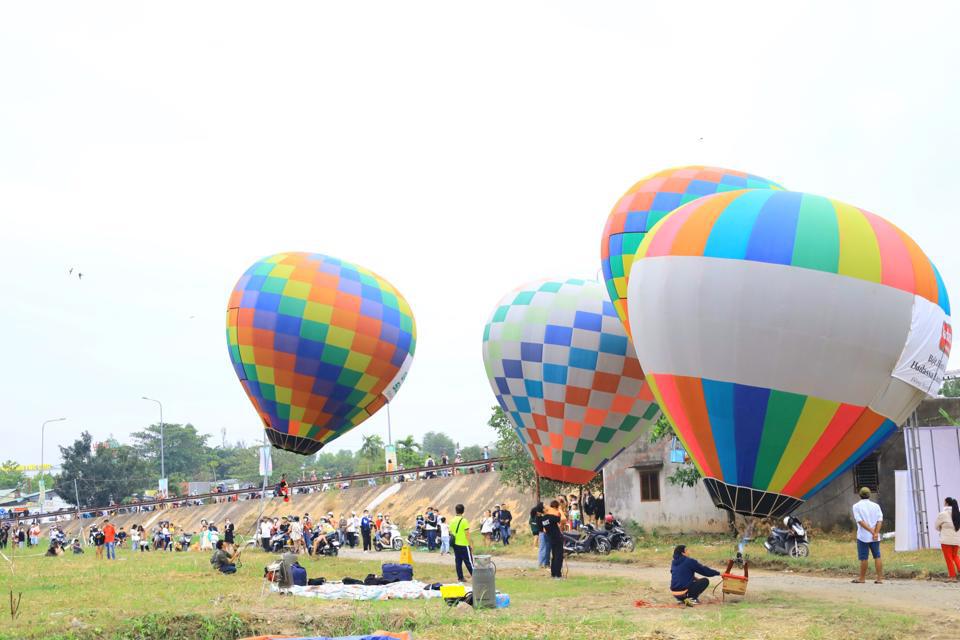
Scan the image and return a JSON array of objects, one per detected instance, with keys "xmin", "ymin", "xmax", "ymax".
[{"xmin": 227, "ymin": 253, "xmax": 417, "ymax": 455}]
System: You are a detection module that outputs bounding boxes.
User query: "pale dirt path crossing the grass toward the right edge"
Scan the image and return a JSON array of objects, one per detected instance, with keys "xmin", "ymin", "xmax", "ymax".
[{"xmin": 341, "ymin": 549, "xmax": 960, "ymax": 619}]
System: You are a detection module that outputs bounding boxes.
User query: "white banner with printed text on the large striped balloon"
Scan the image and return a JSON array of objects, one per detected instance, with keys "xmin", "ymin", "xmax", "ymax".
[{"xmin": 893, "ymin": 296, "xmax": 953, "ymax": 395}]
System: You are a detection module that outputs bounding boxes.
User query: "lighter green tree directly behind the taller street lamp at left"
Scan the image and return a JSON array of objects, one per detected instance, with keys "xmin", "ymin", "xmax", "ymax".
[{"xmin": 130, "ymin": 423, "xmax": 214, "ymax": 484}]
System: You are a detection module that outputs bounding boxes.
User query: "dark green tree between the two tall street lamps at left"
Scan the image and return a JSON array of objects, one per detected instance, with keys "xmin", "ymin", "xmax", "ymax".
[{"xmin": 56, "ymin": 431, "xmax": 148, "ymax": 506}]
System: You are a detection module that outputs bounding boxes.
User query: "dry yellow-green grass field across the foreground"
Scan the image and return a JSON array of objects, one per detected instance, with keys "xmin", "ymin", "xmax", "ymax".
[{"xmin": 0, "ymin": 546, "xmax": 928, "ymax": 640}]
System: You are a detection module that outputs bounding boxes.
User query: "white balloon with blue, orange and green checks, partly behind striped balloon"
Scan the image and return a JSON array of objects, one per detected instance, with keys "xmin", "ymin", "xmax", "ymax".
[{"xmin": 483, "ymin": 280, "xmax": 660, "ymax": 484}]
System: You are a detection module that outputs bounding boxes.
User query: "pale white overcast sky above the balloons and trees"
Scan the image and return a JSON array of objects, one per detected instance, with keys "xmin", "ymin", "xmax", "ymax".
[{"xmin": 0, "ymin": 0, "xmax": 960, "ymax": 463}]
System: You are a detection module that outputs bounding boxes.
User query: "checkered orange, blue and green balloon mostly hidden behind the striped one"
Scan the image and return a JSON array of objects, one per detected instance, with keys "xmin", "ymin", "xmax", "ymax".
[{"xmin": 600, "ymin": 166, "xmax": 783, "ymax": 335}]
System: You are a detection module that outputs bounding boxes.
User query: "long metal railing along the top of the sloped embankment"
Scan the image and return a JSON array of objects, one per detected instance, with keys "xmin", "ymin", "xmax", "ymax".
[{"xmin": 0, "ymin": 458, "xmax": 506, "ymax": 526}]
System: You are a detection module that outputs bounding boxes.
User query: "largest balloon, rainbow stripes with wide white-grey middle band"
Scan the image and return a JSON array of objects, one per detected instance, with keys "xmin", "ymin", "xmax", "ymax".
[{"xmin": 627, "ymin": 190, "xmax": 952, "ymax": 516}]
